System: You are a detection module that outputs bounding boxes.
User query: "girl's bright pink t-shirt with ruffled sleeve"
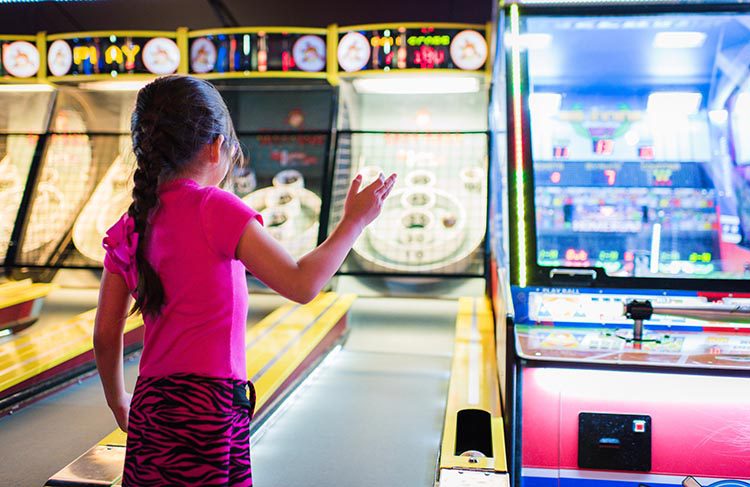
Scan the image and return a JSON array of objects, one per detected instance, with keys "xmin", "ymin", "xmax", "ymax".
[{"xmin": 104, "ymin": 179, "xmax": 263, "ymax": 380}]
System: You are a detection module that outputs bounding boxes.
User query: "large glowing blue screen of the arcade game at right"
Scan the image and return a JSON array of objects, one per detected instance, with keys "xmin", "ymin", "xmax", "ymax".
[{"xmin": 521, "ymin": 14, "xmax": 750, "ymax": 279}]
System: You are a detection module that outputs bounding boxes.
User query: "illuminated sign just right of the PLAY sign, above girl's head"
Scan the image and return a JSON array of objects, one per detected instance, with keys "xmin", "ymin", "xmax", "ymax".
[{"xmin": 190, "ymin": 31, "xmax": 326, "ymax": 76}]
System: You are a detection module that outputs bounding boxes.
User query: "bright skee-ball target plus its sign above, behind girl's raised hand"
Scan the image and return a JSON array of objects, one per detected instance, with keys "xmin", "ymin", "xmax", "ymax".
[{"xmin": 329, "ymin": 24, "xmax": 489, "ymax": 278}]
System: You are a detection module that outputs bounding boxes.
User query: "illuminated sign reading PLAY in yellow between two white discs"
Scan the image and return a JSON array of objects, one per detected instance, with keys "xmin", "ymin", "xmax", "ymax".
[{"xmin": 47, "ymin": 34, "xmax": 181, "ymax": 77}]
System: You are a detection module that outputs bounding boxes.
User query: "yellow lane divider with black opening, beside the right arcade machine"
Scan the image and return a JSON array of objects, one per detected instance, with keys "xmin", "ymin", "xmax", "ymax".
[{"xmin": 439, "ymin": 298, "xmax": 508, "ymax": 472}]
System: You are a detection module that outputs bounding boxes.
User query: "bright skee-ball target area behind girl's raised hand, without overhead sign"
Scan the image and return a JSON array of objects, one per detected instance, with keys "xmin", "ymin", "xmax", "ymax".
[{"xmin": 331, "ymin": 74, "xmax": 488, "ymax": 275}]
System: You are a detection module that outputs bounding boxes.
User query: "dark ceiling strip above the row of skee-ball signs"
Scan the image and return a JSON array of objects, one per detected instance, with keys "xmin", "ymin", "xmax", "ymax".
[{"xmin": 0, "ymin": 0, "xmax": 493, "ymax": 34}]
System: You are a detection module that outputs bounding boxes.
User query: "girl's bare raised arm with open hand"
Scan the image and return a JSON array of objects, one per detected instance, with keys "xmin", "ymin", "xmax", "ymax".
[{"xmin": 236, "ymin": 174, "xmax": 396, "ymax": 303}]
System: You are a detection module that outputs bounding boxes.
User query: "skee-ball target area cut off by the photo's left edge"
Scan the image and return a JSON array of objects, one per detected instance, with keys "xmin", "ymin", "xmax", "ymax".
[{"xmin": 0, "ymin": 85, "xmax": 54, "ymax": 264}]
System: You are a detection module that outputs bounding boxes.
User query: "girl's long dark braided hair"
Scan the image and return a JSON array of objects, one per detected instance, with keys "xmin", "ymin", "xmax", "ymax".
[{"xmin": 128, "ymin": 75, "xmax": 242, "ymax": 315}]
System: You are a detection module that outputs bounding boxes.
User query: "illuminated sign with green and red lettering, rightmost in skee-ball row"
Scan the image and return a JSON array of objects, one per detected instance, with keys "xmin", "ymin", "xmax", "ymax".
[{"xmin": 338, "ymin": 26, "xmax": 488, "ymax": 72}]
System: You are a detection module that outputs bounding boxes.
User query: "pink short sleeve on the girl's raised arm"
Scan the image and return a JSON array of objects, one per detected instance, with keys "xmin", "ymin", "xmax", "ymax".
[{"xmin": 200, "ymin": 188, "xmax": 263, "ymax": 259}]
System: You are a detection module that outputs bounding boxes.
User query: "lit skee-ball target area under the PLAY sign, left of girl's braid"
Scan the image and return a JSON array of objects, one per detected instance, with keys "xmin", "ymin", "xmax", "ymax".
[{"xmin": 14, "ymin": 87, "xmax": 135, "ymax": 274}]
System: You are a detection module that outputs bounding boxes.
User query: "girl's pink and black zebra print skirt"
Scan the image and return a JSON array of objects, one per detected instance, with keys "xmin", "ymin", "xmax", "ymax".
[{"xmin": 122, "ymin": 374, "xmax": 255, "ymax": 487}]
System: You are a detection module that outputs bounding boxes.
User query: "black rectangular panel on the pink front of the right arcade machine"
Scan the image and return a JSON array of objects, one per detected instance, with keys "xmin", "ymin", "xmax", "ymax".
[{"xmin": 578, "ymin": 413, "xmax": 651, "ymax": 472}]
